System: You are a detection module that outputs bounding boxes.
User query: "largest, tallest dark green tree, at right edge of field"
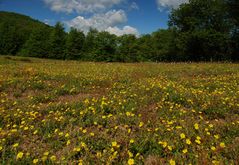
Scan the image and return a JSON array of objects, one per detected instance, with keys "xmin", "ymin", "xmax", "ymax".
[{"xmin": 169, "ymin": 0, "xmax": 231, "ymax": 61}]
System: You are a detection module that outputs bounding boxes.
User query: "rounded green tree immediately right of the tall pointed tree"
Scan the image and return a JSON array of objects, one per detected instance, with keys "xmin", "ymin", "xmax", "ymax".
[{"xmin": 65, "ymin": 28, "xmax": 85, "ymax": 60}]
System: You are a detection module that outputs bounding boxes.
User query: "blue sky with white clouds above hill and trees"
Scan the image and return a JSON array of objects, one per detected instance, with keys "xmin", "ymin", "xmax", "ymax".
[{"xmin": 0, "ymin": 0, "xmax": 187, "ymax": 35}]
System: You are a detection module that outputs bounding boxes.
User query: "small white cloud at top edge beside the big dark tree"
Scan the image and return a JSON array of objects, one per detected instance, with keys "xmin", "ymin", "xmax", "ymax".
[{"xmin": 157, "ymin": 0, "xmax": 188, "ymax": 10}]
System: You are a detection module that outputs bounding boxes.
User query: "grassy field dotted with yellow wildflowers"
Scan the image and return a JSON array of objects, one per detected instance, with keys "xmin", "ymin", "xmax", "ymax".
[{"xmin": 0, "ymin": 57, "xmax": 239, "ymax": 165}]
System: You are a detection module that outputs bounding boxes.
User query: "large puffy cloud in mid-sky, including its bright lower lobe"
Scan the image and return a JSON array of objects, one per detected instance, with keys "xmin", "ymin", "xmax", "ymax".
[{"xmin": 65, "ymin": 10, "xmax": 138, "ymax": 36}]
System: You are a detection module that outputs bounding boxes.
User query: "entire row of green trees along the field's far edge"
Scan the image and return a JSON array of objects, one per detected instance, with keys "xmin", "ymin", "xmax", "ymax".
[{"xmin": 0, "ymin": 0, "xmax": 239, "ymax": 62}]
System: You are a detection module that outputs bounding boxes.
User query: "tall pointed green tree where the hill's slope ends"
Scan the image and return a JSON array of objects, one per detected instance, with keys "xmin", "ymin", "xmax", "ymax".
[{"xmin": 49, "ymin": 22, "xmax": 66, "ymax": 59}]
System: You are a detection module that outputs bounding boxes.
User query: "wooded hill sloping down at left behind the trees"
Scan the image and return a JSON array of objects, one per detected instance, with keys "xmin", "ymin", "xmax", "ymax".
[{"xmin": 0, "ymin": 11, "xmax": 52, "ymax": 55}]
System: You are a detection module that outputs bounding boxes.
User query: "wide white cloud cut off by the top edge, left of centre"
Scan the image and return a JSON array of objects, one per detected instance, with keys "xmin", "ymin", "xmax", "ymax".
[{"xmin": 43, "ymin": 0, "xmax": 125, "ymax": 13}]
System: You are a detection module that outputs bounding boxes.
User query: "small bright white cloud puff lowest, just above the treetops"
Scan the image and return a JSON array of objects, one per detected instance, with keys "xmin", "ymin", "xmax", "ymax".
[{"xmin": 105, "ymin": 26, "xmax": 139, "ymax": 36}]
